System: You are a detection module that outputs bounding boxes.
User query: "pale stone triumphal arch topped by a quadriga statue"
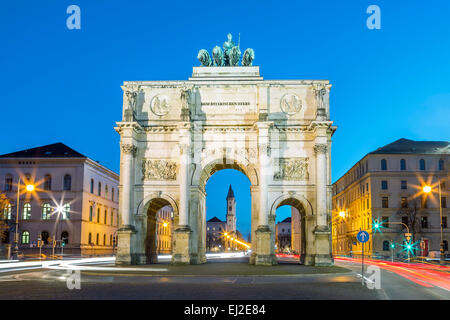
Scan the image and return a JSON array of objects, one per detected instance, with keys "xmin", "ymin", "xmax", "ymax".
[{"xmin": 115, "ymin": 36, "xmax": 336, "ymax": 265}]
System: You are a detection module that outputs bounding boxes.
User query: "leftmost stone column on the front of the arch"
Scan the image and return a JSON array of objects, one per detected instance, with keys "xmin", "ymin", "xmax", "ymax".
[{"xmin": 116, "ymin": 143, "xmax": 137, "ymax": 265}]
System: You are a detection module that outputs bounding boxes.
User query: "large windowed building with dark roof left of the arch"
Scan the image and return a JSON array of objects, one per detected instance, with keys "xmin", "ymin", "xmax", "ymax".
[{"xmin": 0, "ymin": 143, "xmax": 119, "ymax": 254}]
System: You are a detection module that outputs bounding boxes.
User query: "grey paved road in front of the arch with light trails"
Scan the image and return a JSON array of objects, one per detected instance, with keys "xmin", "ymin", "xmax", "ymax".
[{"xmin": 0, "ymin": 258, "xmax": 449, "ymax": 300}]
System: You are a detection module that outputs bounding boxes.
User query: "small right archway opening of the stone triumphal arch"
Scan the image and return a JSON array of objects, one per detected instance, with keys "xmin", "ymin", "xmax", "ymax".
[{"xmin": 275, "ymin": 198, "xmax": 306, "ymax": 264}]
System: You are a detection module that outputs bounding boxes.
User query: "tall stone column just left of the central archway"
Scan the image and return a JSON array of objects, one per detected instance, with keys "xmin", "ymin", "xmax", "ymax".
[{"xmin": 172, "ymin": 122, "xmax": 192, "ymax": 264}]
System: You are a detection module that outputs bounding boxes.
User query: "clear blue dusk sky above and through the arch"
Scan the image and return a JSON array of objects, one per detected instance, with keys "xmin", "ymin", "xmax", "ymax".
[{"xmin": 0, "ymin": 0, "xmax": 450, "ymax": 240}]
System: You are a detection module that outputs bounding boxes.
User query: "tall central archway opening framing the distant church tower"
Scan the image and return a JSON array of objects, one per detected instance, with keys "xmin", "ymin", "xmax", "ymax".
[{"xmin": 205, "ymin": 165, "xmax": 252, "ymax": 263}]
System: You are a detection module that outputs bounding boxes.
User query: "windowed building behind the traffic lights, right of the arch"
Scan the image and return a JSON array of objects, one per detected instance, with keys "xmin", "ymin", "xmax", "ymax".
[{"xmin": 332, "ymin": 139, "xmax": 450, "ymax": 257}]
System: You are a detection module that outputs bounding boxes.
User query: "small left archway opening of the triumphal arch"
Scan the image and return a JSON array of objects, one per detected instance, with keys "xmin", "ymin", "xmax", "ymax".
[{"xmin": 144, "ymin": 198, "xmax": 174, "ymax": 264}]
